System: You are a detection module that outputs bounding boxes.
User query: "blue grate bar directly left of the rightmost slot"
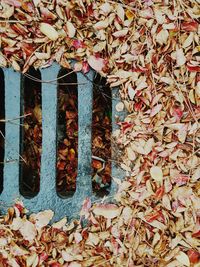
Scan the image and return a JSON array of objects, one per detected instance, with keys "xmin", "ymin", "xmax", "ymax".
[{"xmin": 75, "ymin": 71, "xmax": 94, "ymax": 201}]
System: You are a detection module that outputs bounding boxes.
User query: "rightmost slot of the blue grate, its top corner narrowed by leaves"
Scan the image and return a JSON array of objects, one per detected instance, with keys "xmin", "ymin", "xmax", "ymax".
[{"xmin": 92, "ymin": 74, "xmax": 112, "ymax": 197}]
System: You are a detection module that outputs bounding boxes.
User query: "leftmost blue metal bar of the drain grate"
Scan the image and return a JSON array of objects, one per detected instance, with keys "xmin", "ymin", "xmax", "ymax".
[{"xmin": 1, "ymin": 69, "xmax": 22, "ymax": 205}]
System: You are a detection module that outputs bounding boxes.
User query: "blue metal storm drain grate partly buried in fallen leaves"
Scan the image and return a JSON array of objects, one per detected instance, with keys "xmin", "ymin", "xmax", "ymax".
[{"xmin": 0, "ymin": 64, "xmax": 124, "ymax": 220}]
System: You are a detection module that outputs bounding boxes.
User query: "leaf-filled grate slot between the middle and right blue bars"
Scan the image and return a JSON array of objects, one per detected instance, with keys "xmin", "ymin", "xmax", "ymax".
[{"xmin": 56, "ymin": 68, "xmax": 78, "ymax": 197}]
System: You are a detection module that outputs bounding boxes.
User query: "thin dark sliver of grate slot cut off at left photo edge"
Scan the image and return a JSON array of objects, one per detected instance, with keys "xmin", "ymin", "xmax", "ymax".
[{"xmin": 0, "ymin": 69, "xmax": 5, "ymax": 193}]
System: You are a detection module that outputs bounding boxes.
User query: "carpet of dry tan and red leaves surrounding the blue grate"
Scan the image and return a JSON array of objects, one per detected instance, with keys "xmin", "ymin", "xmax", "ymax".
[{"xmin": 0, "ymin": 0, "xmax": 200, "ymax": 267}]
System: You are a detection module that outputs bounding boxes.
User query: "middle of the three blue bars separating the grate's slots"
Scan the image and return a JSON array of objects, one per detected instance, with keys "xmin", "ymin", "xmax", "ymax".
[{"xmin": 40, "ymin": 64, "xmax": 59, "ymax": 199}]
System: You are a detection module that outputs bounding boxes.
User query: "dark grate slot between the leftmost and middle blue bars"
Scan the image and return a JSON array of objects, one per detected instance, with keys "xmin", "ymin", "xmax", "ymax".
[{"xmin": 19, "ymin": 68, "xmax": 42, "ymax": 198}]
